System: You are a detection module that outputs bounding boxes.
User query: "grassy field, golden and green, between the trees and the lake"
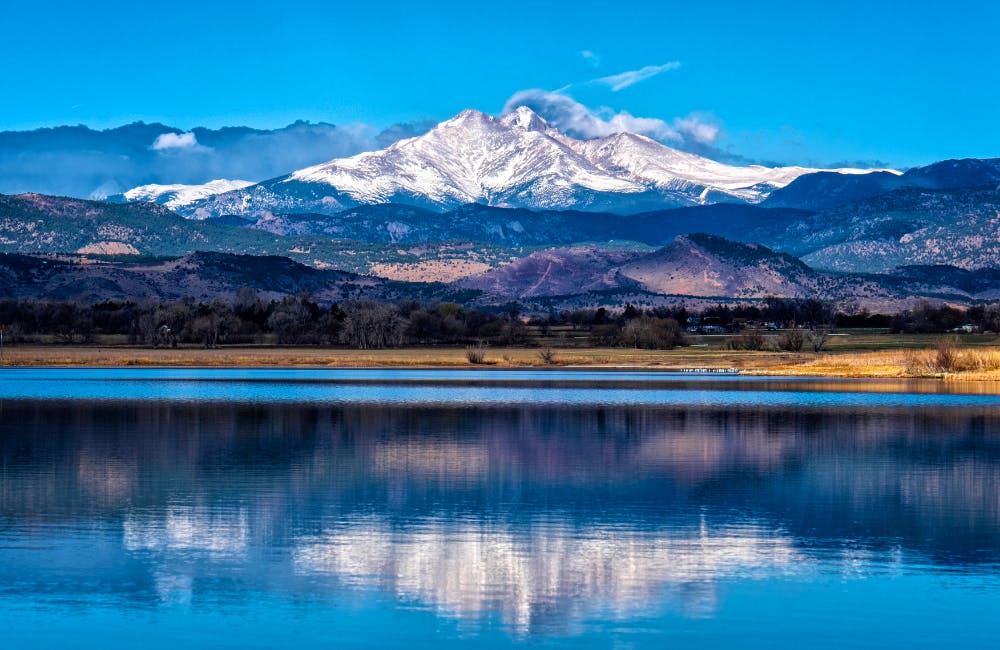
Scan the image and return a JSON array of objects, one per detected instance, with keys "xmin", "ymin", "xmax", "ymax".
[{"xmin": 0, "ymin": 331, "xmax": 1000, "ymax": 381}]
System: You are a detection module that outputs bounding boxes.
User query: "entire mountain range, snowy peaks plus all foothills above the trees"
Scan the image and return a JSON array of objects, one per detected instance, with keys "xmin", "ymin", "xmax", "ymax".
[{"xmin": 0, "ymin": 107, "xmax": 1000, "ymax": 311}]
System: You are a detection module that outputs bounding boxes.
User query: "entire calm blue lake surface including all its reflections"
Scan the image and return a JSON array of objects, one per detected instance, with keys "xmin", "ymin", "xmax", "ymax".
[{"xmin": 0, "ymin": 369, "xmax": 1000, "ymax": 650}]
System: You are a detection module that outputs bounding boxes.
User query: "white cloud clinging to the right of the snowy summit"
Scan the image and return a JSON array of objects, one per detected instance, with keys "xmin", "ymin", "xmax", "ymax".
[{"xmin": 503, "ymin": 89, "xmax": 721, "ymax": 150}]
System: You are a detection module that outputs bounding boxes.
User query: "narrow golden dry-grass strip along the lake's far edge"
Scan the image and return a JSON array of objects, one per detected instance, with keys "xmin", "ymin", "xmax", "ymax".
[{"xmin": 0, "ymin": 345, "xmax": 1000, "ymax": 384}]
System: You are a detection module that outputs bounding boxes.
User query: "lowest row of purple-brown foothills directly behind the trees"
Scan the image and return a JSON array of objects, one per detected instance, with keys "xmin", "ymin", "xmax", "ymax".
[{"xmin": 7, "ymin": 234, "xmax": 1000, "ymax": 313}]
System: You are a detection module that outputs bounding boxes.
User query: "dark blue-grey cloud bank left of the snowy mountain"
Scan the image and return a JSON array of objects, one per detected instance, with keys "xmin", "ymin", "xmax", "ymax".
[{"xmin": 0, "ymin": 121, "xmax": 430, "ymax": 198}]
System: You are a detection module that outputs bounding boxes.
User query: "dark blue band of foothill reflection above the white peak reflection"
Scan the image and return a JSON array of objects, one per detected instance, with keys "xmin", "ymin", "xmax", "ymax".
[{"xmin": 0, "ymin": 402, "xmax": 1000, "ymax": 561}]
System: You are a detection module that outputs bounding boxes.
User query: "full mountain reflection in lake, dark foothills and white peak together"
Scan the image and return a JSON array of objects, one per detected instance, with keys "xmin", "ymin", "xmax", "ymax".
[{"xmin": 0, "ymin": 400, "xmax": 1000, "ymax": 637}]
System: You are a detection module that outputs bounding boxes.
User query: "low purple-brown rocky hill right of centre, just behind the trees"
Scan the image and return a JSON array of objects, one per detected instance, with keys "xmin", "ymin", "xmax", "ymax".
[{"xmin": 456, "ymin": 234, "xmax": 1000, "ymax": 310}]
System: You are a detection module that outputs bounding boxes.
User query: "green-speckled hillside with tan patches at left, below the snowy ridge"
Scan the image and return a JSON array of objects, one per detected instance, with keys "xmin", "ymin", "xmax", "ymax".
[{"xmin": 0, "ymin": 194, "xmax": 530, "ymax": 280}]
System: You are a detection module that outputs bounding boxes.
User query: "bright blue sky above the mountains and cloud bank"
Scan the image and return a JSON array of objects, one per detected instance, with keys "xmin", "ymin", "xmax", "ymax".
[{"xmin": 0, "ymin": 0, "xmax": 1000, "ymax": 166}]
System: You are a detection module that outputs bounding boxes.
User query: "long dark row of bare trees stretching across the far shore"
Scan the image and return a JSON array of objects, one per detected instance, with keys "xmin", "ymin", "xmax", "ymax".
[{"xmin": 0, "ymin": 294, "xmax": 1000, "ymax": 349}]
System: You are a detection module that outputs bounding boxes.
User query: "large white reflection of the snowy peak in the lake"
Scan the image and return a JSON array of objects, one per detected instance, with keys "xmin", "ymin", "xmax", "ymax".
[{"xmin": 294, "ymin": 516, "xmax": 802, "ymax": 631}]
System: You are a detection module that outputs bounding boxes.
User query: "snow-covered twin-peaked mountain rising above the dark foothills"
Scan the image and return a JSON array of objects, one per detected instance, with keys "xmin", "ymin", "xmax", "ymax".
[{"xmin": 150, "ymin": 106, "xmax": 900, "ymax": 218}]
